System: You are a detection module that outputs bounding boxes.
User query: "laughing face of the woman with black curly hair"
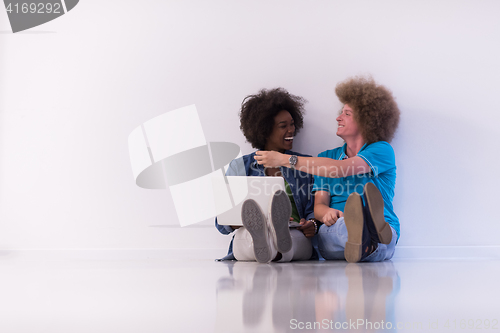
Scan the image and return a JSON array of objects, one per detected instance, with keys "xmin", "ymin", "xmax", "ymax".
[{"xmin": 265, "ymin": 110, "xmax": 295, "ymax": 152}]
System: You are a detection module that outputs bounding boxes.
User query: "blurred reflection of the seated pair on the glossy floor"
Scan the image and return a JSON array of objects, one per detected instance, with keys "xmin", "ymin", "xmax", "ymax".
[{"xmin": 216, "ymin": 261, "xmax": 400, "ymax": 332}]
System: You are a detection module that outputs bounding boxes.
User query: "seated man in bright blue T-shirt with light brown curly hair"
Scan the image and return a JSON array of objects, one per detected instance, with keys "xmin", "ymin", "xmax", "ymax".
[{"xmin": 255, "ymin": 77, "xmax": 400, "ymax": 262}]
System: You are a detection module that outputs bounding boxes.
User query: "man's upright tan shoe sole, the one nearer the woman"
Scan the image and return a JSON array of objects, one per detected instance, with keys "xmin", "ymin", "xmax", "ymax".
[{"xmin": 344, "ymin": 192, "xmax": 364, "ymax": 262}]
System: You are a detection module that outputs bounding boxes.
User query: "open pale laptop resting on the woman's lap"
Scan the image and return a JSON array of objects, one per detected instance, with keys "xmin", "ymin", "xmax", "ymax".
[{"xmin": 212, "ymin": 176, "xmax": 285, "ymax": 226}]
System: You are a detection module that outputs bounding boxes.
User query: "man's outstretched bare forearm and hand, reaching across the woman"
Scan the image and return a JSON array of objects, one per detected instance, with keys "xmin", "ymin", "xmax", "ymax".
[{"xmin": 254, "ymin": 151, "xmax": 371, "ymax": 178}]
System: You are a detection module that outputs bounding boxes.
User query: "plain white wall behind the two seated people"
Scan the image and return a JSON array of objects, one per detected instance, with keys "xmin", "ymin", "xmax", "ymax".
[{"xmin": 0, "ymin": 0, "xmax": 500, "ymax": 249}]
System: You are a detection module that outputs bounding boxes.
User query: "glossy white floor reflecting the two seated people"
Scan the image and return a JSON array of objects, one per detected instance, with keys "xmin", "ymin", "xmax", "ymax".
[{"xmin": 0, "ymin": 250, "xmax": 500, "ymax": 333}]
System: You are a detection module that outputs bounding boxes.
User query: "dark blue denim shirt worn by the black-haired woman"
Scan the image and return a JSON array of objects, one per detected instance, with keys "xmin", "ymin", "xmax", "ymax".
[{"xmin": 215, "ymin": 150, "xmax": 314, "ymax": 260}]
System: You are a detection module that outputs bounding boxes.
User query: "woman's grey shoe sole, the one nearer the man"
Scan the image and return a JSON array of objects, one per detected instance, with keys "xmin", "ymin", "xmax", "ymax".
[{"xmin": 270, "ymin": 190, "xmax": 292, "ymax": 253}]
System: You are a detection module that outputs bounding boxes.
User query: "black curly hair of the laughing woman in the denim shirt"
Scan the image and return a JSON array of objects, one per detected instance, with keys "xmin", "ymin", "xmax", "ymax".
[{"xmin": 240, "ymin": 88, "xmax": 306, "ymax": 149}]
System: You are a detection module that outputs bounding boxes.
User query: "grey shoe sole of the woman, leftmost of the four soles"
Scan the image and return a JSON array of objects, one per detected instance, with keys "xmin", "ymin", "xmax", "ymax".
[{"xmin": 241, "ymin": 199, "xmax": 271, "ymax": 263}]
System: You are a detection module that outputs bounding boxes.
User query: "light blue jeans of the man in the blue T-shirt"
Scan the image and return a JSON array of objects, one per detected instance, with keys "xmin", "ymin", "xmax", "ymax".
[{"xmin": 317, "ymin": 217, "xmax": 398, "ymax": 261}]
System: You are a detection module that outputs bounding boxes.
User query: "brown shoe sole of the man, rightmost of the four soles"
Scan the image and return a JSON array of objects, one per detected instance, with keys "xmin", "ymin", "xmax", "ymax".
[{"xmin": 365, "ymin": 183, "xmax": 392, "ymax": 244}]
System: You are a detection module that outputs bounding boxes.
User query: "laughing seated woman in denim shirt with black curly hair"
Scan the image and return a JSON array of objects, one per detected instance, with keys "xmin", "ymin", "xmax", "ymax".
[{"xmin": 215, "ymin": 88, "xmax": 317, "ymax": 263}]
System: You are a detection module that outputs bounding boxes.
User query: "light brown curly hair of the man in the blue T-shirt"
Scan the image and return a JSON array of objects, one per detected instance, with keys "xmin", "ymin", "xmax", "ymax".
[{"xmin": 335, "ymin": 77, "xmax": 400, "ymax": 144}]
